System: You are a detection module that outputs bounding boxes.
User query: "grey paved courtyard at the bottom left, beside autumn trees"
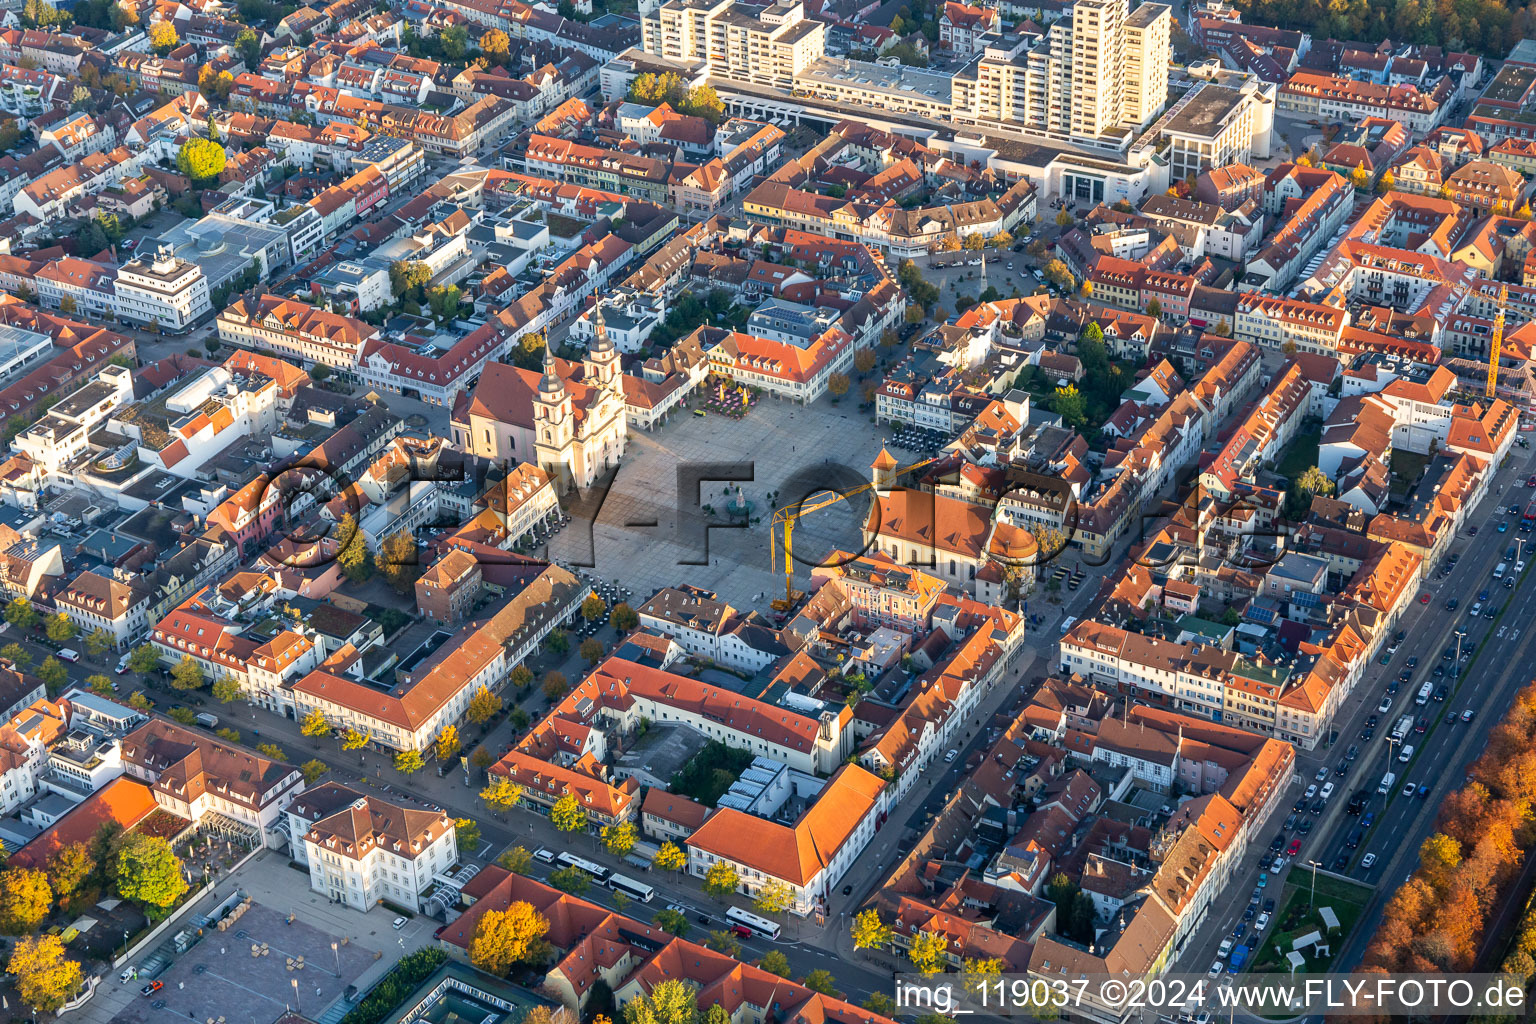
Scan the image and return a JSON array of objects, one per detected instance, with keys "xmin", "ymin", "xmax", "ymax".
[{"xmin": 109, "ymin": 903, "xmax": 375, "ymax": 1024}]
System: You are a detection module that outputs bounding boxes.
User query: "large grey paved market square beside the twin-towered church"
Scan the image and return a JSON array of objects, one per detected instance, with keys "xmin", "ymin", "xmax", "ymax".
[{"xmin": 548, "ymin": 396, "xmax": 897, "ymax": 608}]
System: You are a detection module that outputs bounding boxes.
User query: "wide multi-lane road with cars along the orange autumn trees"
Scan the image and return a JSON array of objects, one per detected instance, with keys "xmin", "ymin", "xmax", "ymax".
[{"xmin": 1181, "ymin": 436, "xmax": 1536, "ymax": 970}]
